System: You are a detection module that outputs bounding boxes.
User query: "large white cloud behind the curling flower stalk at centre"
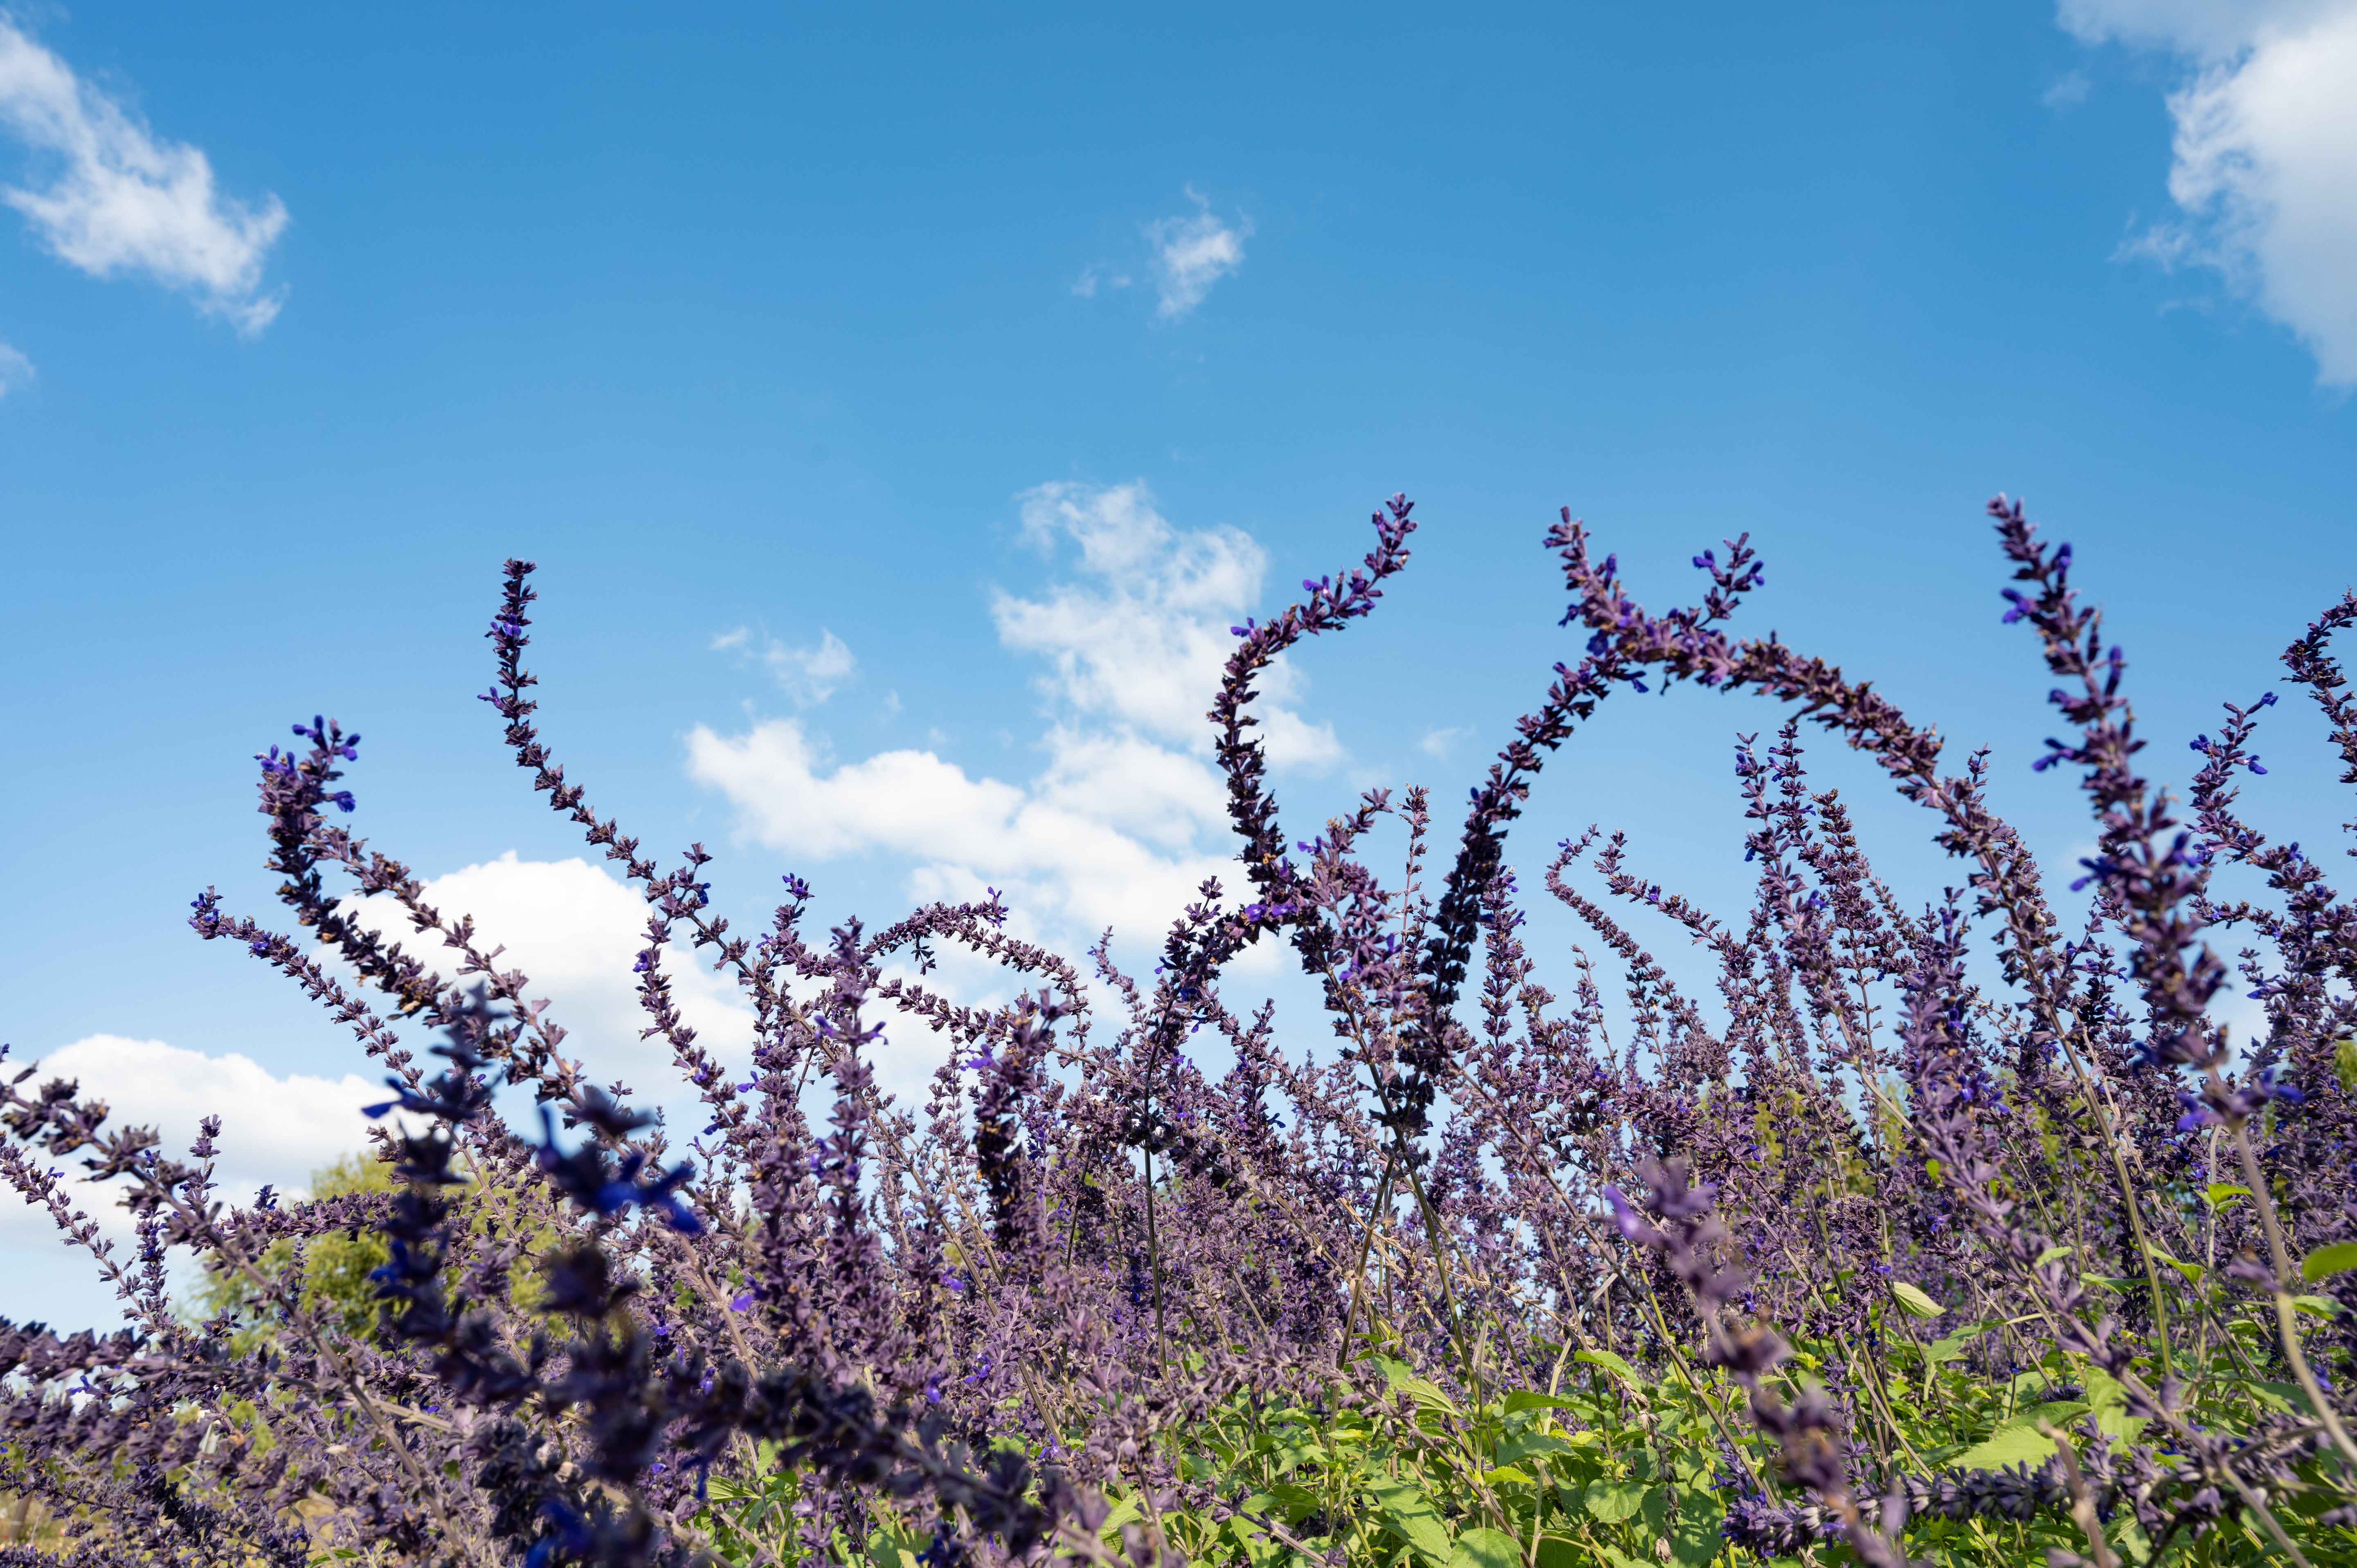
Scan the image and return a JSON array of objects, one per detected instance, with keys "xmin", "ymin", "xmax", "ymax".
[{"xmin": 688, "ymin": 483, "xmax": 1341, "ymax": 941}]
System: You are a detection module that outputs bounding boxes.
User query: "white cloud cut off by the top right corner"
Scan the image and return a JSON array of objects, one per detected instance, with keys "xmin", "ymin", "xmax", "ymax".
[{"xmin": 2062, "ymin": 0, "xmax": 2357, "ymax": 387}]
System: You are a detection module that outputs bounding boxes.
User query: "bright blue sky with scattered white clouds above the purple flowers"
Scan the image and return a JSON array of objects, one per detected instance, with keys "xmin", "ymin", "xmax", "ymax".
[{"xmin": 0, "ymin": 0, "xmax": 2357, "ymax": 1320}]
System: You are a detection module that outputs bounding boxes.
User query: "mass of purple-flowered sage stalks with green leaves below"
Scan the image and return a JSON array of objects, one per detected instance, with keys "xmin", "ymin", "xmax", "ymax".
[{"xmin": 0, "ymin": 498, "xmax": 2357, "ymax": 1568}]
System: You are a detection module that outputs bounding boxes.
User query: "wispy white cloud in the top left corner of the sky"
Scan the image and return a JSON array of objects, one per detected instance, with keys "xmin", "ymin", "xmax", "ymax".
[{"xmin": 0, "ymin": 16, "xmax": 288, "ymax": 332}]
